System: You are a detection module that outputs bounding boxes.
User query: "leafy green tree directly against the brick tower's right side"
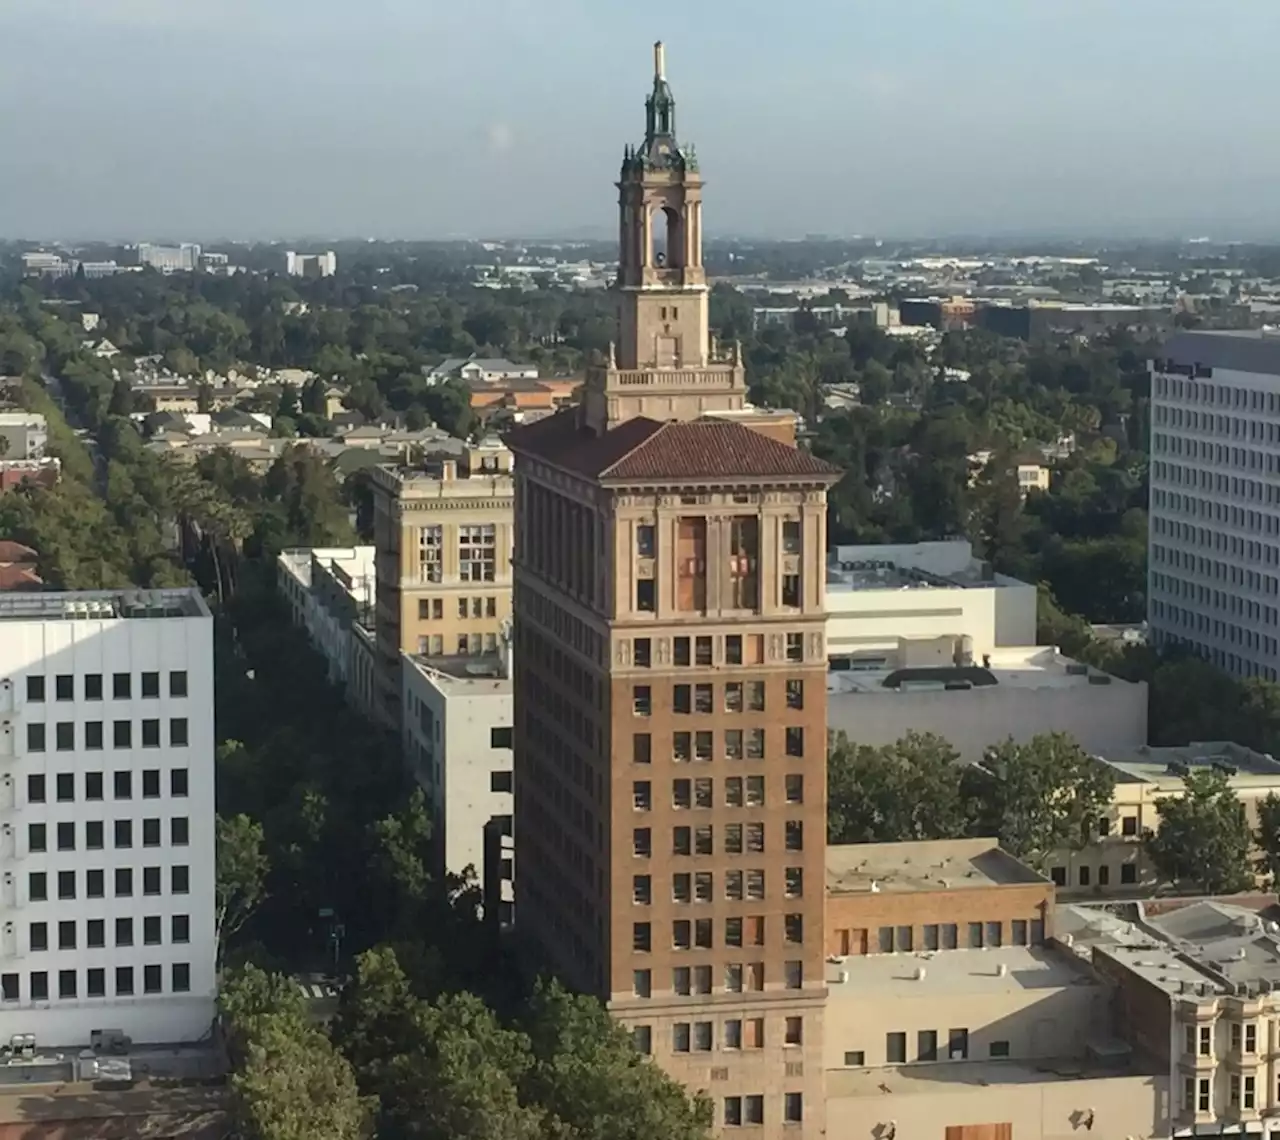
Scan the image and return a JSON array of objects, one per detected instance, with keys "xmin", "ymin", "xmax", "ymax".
[{"xmin": 827, "ymin": 732, "xmax": 966, "ymax": 843}]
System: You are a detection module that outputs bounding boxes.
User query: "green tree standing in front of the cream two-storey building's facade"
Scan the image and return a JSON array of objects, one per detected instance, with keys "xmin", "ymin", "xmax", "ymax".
[{"xmin": 1146, "ymin": 769, "xmax": 1254, "ymax": 894}]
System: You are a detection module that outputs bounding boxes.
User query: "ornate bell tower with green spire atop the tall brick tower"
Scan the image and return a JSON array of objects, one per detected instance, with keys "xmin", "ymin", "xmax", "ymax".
[{"xmin": 584, "ymin": 42, "xmax": 746, "ymax": 431}]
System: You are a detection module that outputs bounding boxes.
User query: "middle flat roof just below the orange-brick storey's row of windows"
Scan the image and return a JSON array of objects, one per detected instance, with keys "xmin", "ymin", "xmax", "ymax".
[{"xmin": 827, "ymin": 946, "xmax": 1103, "ymax": 1002}]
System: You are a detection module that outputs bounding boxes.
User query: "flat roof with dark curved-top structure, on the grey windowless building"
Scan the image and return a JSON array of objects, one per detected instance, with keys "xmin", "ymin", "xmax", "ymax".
[{"xmin": 827, "ymin": 645, "xmax": 1128, "ymax": 696}]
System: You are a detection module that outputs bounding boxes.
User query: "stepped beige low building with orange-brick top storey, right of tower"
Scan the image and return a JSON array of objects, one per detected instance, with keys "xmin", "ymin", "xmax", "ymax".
[{"xmin": 823, "ymin": 839, "xmax": 1169, "ymax": 1140}]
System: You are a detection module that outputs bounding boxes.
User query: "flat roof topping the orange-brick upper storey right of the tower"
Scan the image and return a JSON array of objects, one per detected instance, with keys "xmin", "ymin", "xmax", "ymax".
[{"xmin": 827, "ymin": 839, "xmax": 1048, "ymax": 894}]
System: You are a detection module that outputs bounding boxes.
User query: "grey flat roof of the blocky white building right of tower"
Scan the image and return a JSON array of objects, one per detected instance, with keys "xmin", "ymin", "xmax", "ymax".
[{"xmin": 827, "ymin": 539, "xmax": 1023, "ymax": 592}]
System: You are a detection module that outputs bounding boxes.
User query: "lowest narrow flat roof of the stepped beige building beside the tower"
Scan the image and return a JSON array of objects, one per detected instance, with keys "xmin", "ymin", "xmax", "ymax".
[{"xmin": 827, "ymin": 1041, "xmax": 1161, "ymax": 1095}]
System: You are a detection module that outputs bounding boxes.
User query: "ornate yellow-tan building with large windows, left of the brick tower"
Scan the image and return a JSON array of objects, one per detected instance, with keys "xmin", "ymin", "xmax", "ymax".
[{"xmin": 370, "ymin": 439, "xmax": 515, "ymax": 728}]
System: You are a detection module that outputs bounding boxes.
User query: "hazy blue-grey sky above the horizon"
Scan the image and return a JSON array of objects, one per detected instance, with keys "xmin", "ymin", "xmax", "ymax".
[{"xmin": 0, "ymin": 0, "xmax": 1280, "ymax": 241}]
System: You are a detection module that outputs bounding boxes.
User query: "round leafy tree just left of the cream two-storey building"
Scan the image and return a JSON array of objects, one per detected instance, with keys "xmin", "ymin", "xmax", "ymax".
[{"xmin": 963, "ymin": 732, "xmax": 1115, "ymax": 867}]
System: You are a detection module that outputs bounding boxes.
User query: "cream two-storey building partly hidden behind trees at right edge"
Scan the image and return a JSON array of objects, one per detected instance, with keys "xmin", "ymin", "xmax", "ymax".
[{"xmin": 1047, "ymin": 741, "xmax": 1280, "ymax": 898}]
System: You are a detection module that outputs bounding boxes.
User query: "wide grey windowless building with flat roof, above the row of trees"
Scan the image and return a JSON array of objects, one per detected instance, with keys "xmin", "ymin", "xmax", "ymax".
[{"xmin": 827, "ymin": 638, "xmax": 1147, "ymax": 761}]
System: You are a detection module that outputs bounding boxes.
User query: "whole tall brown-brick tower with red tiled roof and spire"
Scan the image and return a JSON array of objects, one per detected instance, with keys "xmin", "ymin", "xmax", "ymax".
[{"xmin": 509, "ymin": 45, "xmax": 838, "ymax": 1137}]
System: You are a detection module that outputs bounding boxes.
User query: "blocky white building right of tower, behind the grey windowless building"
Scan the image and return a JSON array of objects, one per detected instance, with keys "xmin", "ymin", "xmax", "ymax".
[{"xmin": 827, "ymin": 539, "xmax": 1036, "ymax": 668}]
